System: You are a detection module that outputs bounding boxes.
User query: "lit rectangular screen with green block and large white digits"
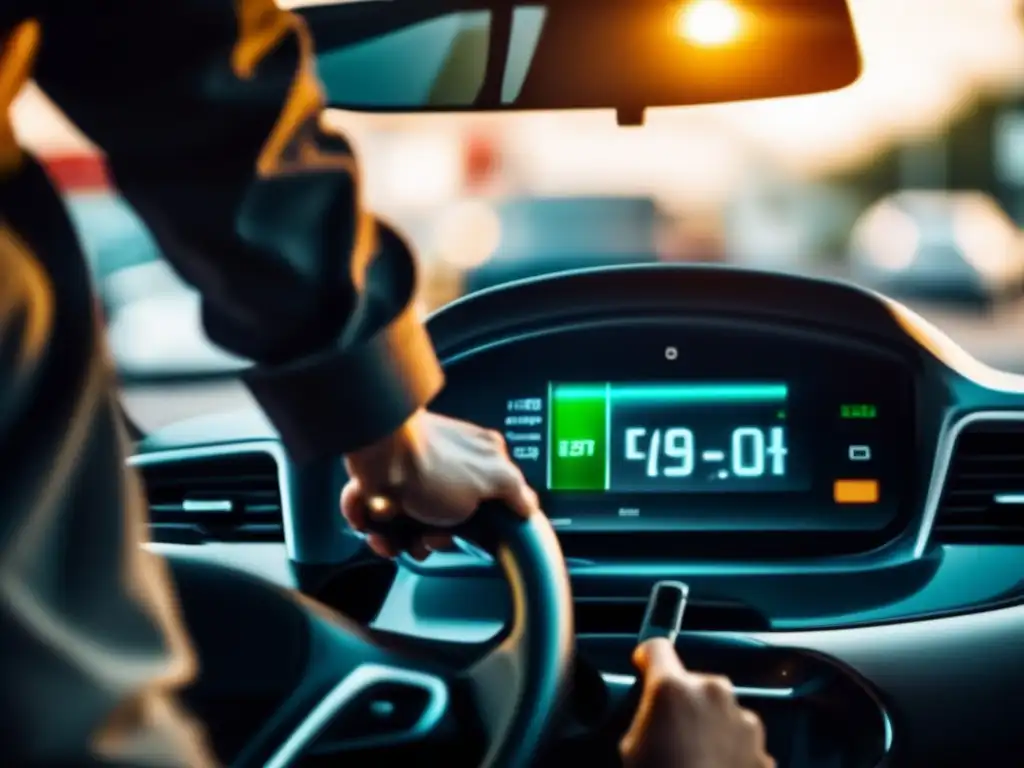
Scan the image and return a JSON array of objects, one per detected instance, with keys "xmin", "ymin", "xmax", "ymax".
[{"xmin": 547, "ymin": 382, "xmax": 811, "ymax": 493}]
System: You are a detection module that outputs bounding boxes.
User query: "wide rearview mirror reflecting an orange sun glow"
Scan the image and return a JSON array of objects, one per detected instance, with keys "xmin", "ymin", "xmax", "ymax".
[{"xmin": 299, "ymin": 0, "xmax": 860, "ymax": 123}]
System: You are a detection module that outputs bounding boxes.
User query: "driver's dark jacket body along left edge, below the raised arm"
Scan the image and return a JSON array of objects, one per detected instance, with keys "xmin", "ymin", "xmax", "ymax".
[{"xmin": 0, "ymin": 143, "xmax": 214, "ymax": 768}]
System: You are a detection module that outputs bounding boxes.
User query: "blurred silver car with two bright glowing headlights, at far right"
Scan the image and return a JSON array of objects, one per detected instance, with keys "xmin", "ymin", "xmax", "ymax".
[{"xmin": 850, "ymin": 190, "xmax": 1024, "ymax": 306}]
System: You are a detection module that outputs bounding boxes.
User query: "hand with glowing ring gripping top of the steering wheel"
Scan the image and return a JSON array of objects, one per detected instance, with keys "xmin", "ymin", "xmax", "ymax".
[{"xmin": 341, "ymin": 411, "xmax": 539, "ymax": 559}]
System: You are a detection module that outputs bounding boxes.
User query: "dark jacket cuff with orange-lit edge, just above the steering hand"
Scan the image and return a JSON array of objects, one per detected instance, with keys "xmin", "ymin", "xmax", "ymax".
[{"xmin": 243, "ymin": 305, "xmax": 444, "ymax": 462}]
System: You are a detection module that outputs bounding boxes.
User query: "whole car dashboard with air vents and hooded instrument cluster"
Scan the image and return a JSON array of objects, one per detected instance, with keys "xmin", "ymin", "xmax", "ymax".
[{"xmin": 132, "ymin": 265, "xmax": 1024, "ymax": 767}]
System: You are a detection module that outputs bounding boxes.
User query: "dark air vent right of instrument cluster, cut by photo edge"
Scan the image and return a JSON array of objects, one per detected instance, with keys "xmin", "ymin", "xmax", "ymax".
[{"xmin": 933, "ymin": 414, "xmax": 1024, "ymax": 544}]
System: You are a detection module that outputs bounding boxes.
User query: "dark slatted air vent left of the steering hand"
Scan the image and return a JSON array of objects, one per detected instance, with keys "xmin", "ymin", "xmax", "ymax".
[{"xmin": 135, "ymin": 451, "xmax": 285, "ymax": 544}]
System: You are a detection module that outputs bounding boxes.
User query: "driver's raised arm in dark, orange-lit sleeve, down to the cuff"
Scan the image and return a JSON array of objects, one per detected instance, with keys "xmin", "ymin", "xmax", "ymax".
[{"xmin": 30, "ymin": 0, "xmax": 442, "ymax": 460}]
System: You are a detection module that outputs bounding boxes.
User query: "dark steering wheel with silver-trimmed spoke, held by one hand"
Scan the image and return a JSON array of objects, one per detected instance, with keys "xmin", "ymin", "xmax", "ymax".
[{"xmin": 187, "ymin": 503, "xmax": 574, "ymax": 768}]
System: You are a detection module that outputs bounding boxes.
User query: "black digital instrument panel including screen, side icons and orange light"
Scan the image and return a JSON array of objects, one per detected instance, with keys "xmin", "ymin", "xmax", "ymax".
[{"xmin": 438, "ymin": 317, "xmax": 914, "ymax": 541}]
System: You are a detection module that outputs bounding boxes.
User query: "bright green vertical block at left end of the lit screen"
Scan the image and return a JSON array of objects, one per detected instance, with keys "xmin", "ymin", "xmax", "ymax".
[{"xmin": 548, "ymin": 384, "xmax": 609, "ymax": 490}]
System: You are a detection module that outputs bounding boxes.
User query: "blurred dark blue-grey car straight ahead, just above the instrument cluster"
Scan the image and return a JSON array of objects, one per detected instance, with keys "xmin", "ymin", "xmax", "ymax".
[{"xmin": 464, "ymin": 196, "xmax": 666, "ymax": 293}]
